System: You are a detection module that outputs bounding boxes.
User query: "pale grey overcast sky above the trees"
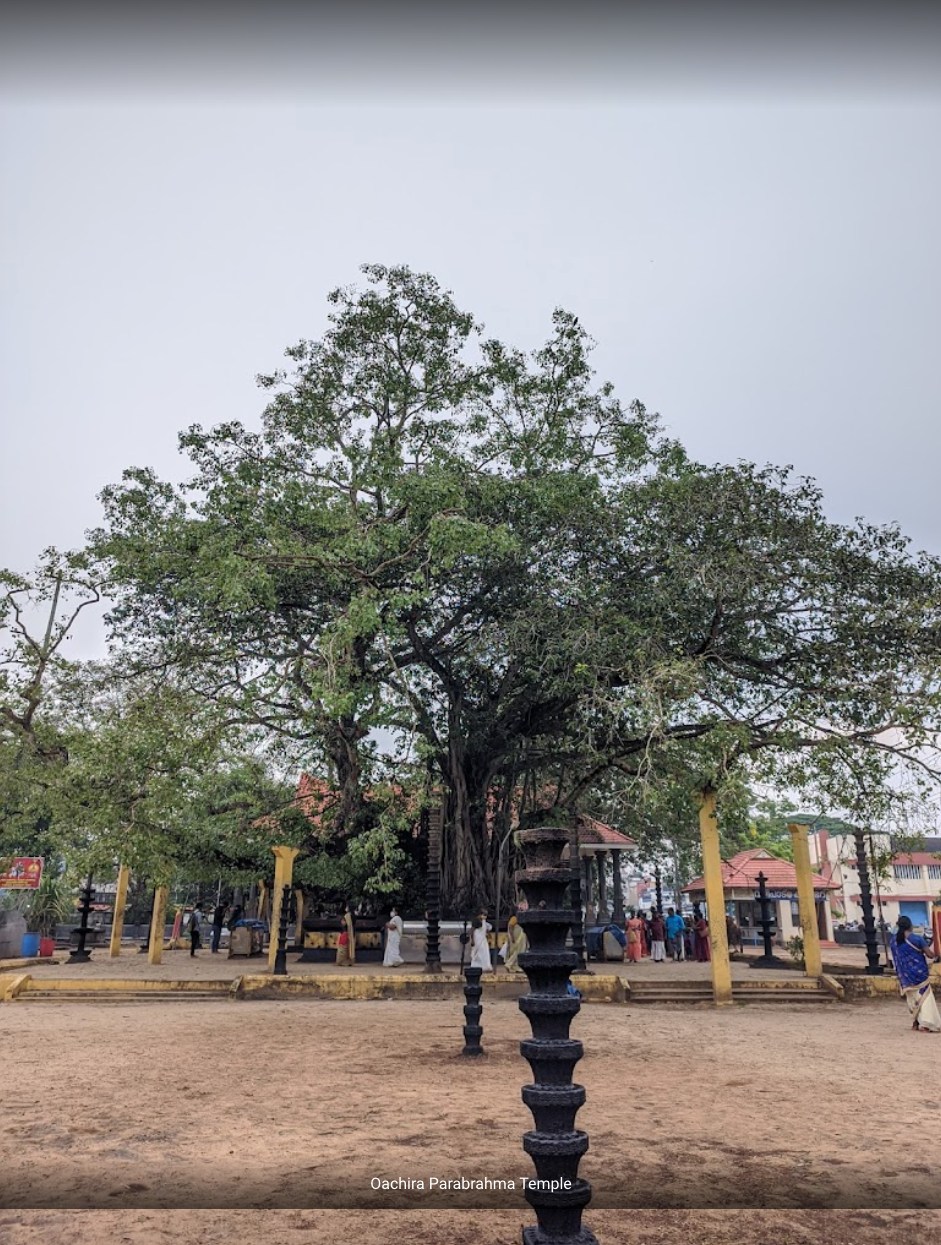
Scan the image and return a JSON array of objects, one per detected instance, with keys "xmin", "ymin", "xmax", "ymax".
[{"xmin": 0, "ymin": 6, "xmax": 941, "ymax": 655}]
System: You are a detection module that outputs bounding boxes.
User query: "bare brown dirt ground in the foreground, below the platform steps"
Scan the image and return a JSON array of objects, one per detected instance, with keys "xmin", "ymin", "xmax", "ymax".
[{"xmin": 0, "ymin": 1000, "xmax": 941, "ymax": 1245}]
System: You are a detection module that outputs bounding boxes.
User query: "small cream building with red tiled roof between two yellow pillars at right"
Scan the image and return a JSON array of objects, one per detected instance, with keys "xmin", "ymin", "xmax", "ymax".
[{"xmin": 683, "ymin": 848, "xmax": 839, "ymax": 945}]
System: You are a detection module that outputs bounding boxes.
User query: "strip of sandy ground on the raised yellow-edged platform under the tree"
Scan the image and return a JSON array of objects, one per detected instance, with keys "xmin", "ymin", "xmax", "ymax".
[{"xmin": 0, "ymin": 944, "xmax": 881, "ymax": 981}]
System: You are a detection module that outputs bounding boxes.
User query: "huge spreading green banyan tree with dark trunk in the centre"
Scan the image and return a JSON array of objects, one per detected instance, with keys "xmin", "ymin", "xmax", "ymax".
[{"xmin": 92, "ymin": 266, "xmax": 941, "ymax": 908}]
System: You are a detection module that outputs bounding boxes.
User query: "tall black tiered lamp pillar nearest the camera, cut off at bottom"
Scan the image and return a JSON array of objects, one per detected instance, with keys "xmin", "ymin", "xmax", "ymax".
[{"xmin": 517, "ymin": 828, "xmax": 597, "ymax": 1245}]
